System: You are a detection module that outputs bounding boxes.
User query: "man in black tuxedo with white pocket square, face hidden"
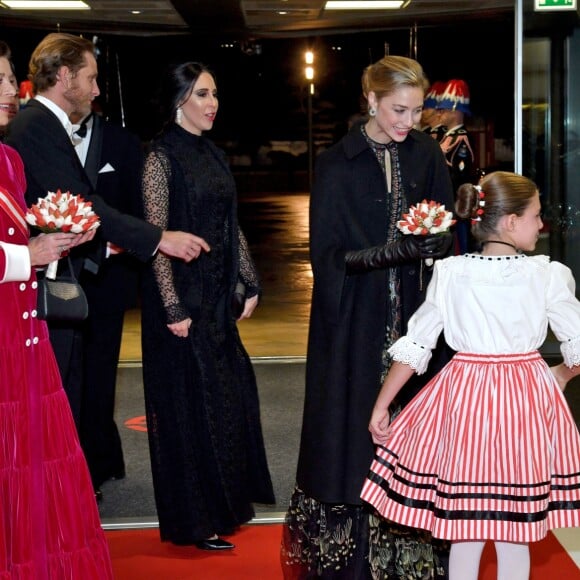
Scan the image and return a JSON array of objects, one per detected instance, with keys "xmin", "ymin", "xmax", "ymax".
[{"xmin": 71, "ymin": 113, "xmax": 143, "ymax": 497}]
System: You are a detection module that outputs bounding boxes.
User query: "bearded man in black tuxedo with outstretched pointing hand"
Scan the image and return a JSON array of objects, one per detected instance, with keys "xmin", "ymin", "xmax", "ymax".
[{"xmin": 6, "ymin": 33, "xmax": 209, "ymax": 438}]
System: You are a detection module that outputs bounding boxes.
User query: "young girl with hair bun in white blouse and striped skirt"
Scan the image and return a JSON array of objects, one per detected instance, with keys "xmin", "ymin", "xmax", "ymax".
[{"xmin": 362, "ymin": 172, "xmax": 580, "ymax": 580}]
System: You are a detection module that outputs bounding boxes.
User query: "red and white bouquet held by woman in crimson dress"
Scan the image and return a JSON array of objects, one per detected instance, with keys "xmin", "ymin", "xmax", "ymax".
[{"xmin": 25, "ymin": 189, "xmax": 101, "ymax": 279}]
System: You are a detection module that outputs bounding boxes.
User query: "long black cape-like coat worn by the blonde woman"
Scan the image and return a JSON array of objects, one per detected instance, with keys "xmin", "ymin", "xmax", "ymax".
[{"xmin": 297, "ymin": 125, "xmax": 453, "ymax": 504}]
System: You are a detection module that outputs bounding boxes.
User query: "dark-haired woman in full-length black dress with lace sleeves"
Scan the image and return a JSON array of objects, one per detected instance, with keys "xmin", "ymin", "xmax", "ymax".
[{"xmin": 142, "ymin": 62, "xmax": 274, "ymax": 550}]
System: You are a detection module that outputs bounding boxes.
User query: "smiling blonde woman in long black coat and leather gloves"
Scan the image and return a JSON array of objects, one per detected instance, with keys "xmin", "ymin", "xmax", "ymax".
[{"xmin": 282, "ymin": 56, "xmax": 453, "ymax": 580}]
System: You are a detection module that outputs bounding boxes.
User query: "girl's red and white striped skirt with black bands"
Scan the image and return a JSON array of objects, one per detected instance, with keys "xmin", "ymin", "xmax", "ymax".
[{"xmin": 361, "ymin": 351, "xmax": 580, "ymax": 542}]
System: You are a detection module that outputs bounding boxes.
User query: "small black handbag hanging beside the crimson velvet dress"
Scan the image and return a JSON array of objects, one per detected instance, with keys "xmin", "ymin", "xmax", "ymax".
[{"xmin": 36, "ymin": 256, "xmax": 89, "ymax": 322}]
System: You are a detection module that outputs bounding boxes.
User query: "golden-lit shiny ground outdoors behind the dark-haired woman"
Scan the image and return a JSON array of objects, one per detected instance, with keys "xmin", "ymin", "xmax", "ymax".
[{"xmin": 116, "ymin": 193, "xmax": 312, "ymax": 363}]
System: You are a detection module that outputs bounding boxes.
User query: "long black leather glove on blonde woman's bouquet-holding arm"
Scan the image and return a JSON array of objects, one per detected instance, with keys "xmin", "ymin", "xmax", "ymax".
[{"xmin": 344, "ymin": 232, "xmax": 453, "ymax": 274}]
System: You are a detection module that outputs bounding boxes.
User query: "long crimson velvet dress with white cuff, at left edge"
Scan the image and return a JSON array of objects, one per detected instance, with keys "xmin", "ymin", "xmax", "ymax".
[{"xmin": 0, "ymin": 144, "xmax": 113, "ymax": 580}]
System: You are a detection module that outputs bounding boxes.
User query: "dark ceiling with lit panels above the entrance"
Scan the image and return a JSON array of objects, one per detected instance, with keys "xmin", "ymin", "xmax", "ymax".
[{"xmin": 0, "ymin": 0, "xmax": 515, "ymax": 40}]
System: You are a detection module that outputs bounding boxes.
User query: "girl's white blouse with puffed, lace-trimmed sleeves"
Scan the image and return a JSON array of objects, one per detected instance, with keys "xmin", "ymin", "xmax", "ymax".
[{"xmin": 389, "ymin": 254, "xmax": 580, "ymax": 374}]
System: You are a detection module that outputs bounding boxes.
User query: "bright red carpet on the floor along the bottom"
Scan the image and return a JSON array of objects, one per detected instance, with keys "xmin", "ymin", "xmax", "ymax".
[{"xmin": 106, "ymin": 524, "xmax": 580, "ymax": 580}]
